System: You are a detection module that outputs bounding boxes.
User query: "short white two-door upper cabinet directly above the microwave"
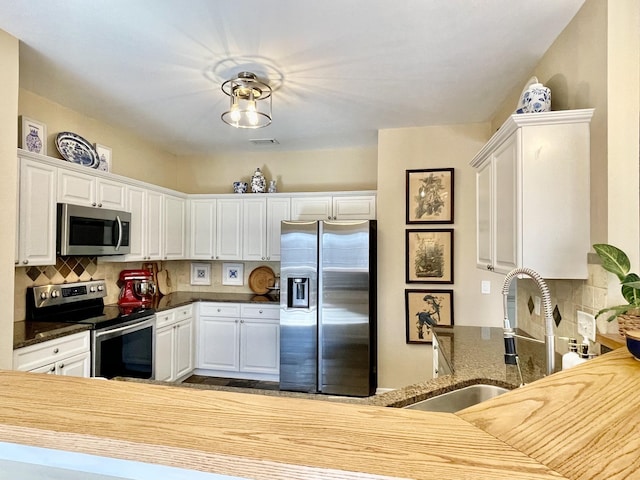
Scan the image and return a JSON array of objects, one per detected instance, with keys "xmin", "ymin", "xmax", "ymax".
[{"xmin": 58, "ymin": 169, "xmax": 127, "ymax": 210}]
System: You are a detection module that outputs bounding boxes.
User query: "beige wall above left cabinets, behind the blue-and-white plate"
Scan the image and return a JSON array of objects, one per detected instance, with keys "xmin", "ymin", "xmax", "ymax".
[{"xmin": 19, "ymin": 88, "xmax": 177, "ymax": 190}]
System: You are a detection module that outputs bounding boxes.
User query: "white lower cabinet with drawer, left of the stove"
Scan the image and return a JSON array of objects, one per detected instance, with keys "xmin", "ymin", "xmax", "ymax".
[{"xmin": 13, "ymin": 331, "xmax": 91, "ymax": 377}]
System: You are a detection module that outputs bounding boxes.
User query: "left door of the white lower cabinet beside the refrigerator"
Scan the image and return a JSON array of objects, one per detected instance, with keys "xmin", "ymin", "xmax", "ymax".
[{"xmin": 198, "ymin": 317, "xmax": 240, "ymax": 372}]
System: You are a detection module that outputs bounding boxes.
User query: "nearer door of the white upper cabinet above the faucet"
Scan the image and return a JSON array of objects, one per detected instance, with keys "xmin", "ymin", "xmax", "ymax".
[{"xmin": 492, "ymin": 135, "xmax": 520, "ymax": 273}]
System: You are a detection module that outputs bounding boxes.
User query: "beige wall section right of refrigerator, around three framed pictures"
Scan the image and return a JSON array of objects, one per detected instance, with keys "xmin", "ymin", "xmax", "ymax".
[{"xmin": 378, "ymin": 123, "xmax": 502, "ymax": 388}]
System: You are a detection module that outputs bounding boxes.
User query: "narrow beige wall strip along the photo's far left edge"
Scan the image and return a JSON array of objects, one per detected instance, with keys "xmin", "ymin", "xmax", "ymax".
[{"xmin": 0, "ymin": 31, "xmax": 18, "ymax": 368}]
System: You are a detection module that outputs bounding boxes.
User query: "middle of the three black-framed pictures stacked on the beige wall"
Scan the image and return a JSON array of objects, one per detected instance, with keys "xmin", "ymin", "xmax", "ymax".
[{"xmin": 406, "ymin": 228, "xmax": 453, "ymax": 283}]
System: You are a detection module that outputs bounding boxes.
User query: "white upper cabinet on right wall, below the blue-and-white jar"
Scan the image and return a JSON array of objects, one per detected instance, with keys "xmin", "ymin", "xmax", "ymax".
[{"xmin": 471, "ymin": 109, "xmax": 593, "ymax": 279}]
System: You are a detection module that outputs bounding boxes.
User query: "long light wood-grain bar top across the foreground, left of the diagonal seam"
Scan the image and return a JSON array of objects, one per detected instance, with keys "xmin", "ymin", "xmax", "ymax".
[{"xmin": 0, "ymin": 371, "xmax": 565, "ymax": 480}]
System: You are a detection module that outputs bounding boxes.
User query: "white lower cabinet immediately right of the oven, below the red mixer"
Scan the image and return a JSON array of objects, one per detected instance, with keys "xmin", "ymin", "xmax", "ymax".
[{"xmin": 154, "ymin": 305, "xmax": 194, "ymax": 382}]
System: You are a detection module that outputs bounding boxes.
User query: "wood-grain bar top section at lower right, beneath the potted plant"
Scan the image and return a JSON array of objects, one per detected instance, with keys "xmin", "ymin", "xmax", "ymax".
[{"xmin": 457, "ymin": 347, "xmax": 640, "ymax": 480}]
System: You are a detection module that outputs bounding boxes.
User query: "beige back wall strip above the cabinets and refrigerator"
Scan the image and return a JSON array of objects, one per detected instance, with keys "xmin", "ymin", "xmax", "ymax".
[{"xmin": 172, "ymin": 147, "xmax": 377, "ymax": 193}]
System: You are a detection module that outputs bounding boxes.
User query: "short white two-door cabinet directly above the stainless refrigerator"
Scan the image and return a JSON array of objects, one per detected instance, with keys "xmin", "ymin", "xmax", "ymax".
[{"xmin": 291, "ymin": 195, "xmax": 376, "ymax": 221}]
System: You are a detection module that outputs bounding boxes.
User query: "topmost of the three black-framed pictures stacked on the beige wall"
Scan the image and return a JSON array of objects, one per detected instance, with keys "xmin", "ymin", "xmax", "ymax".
[{"xmin": 407, "ymin": 168, "xmax": 453, "ymax": 224}]
